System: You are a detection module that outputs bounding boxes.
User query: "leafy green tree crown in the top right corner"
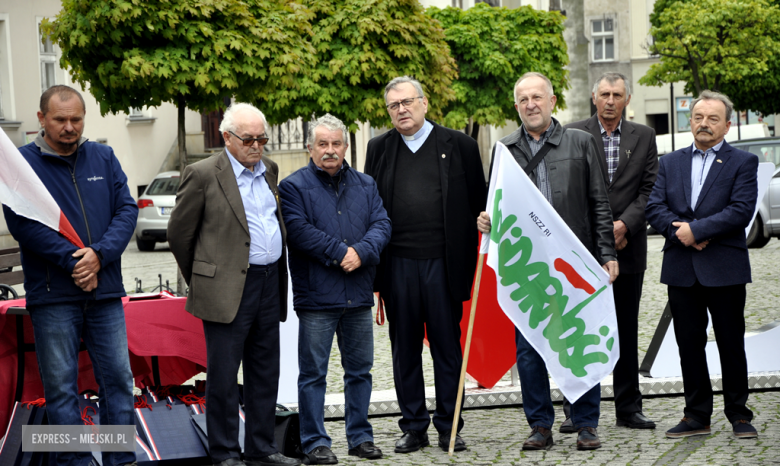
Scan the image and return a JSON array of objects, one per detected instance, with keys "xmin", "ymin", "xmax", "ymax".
[{"xmin": 639, "ymin": 0, "xmax": 780, "ymax": 114}]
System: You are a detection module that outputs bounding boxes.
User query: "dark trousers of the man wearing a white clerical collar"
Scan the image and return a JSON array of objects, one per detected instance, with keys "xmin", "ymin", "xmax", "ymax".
[{"xmin": 382, "ymin": 256, "xmax": 463, "ymax": 433}]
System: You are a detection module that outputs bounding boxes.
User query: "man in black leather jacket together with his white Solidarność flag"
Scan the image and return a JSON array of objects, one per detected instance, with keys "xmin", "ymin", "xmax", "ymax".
[{"xmin": 477, "ymin": 73, "xmax": 619, "ymax": 450}]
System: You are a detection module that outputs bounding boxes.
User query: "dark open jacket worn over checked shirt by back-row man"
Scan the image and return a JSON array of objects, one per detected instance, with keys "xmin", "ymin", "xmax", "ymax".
[{"xmin": 566, "ymin": 115, "xmax": 658, "ymax": 274}]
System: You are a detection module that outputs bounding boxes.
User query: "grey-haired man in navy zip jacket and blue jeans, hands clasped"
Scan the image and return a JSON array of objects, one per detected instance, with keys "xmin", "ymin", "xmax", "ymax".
[{"xmin": 279, "ymin": 114, "xmax": 390, "ymax": 464}]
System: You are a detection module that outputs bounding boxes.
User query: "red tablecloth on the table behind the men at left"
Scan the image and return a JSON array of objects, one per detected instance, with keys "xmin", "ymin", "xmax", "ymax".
[{"xmin": 0, "ymin": 295, "xmax": 206, "ymax": 432}]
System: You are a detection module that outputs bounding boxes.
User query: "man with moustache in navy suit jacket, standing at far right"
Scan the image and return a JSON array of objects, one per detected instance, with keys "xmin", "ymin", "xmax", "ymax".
[{"xmin": 646, "ymin": 91, "xmax": 758, "ymax": 438}]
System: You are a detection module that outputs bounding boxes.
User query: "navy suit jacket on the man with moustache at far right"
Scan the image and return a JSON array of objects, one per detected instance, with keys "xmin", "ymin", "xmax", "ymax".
[{"xmin": 646, "ymin": 142, "xmax": 758, "ymax": 286}]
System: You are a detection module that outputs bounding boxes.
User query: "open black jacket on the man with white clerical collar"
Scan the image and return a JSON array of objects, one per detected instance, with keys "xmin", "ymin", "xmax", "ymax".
[{"xmin": 364, "ymin": 123, "xmax": 487, "ymax": 301}]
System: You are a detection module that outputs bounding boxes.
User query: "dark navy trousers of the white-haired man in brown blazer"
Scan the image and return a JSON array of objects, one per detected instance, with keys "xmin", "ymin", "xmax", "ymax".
[{"xmin": 203, "ymin": 264, "xmax": 280, "ymax": 463}]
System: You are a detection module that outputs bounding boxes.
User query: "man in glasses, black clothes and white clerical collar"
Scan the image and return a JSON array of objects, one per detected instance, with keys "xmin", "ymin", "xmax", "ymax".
[{"xmin": 365, "ymin": 76, "xmax": 487, "ymax": 453}]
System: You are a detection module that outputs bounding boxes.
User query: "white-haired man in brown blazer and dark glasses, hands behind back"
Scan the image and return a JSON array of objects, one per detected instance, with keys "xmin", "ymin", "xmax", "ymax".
[{"xmin": 168, "ymin": 103, "xmax": 300, "ymax": 466}]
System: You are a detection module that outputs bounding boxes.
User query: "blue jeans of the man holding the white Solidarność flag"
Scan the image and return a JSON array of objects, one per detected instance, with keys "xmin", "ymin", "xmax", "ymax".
[{"xmin": 515, "ymin": 328, "xmax": 601, "ymax": 429}]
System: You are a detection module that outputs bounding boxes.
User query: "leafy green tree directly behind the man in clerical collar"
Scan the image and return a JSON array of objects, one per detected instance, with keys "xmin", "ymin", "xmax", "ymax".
[{"xmin": 264, "ymin": 0, "xmax": 457, "ymax": 164}]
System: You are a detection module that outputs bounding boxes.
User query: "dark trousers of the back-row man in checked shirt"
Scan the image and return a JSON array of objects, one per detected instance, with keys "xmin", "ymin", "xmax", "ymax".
[{"xmin": 612, "ymin": 272, "xmax": 645, "ymax": 418}]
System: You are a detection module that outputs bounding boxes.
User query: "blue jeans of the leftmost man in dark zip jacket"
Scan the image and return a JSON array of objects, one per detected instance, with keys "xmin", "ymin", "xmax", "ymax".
[{"xmin": 28, "ymin": 298, "xmax": 135, "ymax": 466}]
